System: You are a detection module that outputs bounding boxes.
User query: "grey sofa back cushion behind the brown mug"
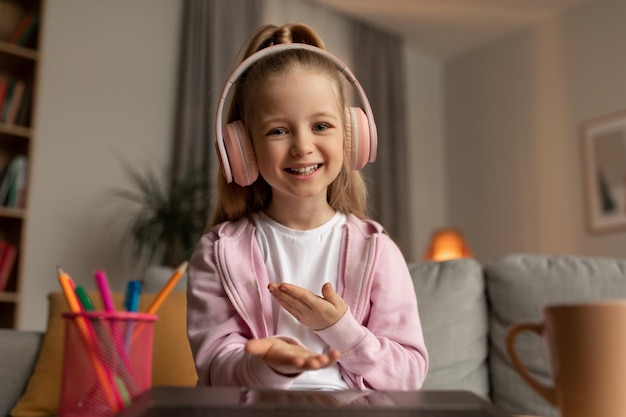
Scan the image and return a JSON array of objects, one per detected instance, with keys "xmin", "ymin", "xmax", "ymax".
[{"xmin": 485, "ymin": 254, "xmax": 626, "ymax": 417}]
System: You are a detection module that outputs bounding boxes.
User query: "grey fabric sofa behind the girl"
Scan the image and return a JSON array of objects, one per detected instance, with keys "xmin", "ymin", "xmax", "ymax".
[{"xmin": 0, "ymin": 255, "xmax": 626, "ymax": 417}]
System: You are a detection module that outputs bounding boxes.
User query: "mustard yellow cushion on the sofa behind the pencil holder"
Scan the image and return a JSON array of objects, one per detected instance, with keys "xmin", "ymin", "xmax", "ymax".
[{"xmin": 11, "ymin": 291, "xmax": 197, "ymax": 417}]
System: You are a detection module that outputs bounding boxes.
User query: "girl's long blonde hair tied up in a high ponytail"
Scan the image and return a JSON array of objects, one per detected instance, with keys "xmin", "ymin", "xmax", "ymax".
[{"xmin": 207, "ymin": 23, "xmax": 367, "ymax": 228}]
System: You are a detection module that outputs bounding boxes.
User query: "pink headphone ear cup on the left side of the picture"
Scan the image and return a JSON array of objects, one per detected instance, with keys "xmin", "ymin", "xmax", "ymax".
[{"xmin": 224, "ymin": 120, "xmax": 259, "ymax": 187}]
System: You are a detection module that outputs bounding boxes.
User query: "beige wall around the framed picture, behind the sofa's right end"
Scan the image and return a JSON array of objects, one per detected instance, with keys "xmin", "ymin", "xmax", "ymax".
[{"xmin": 445, "ymin": 0, "xmax": 626, "ymax": 261}]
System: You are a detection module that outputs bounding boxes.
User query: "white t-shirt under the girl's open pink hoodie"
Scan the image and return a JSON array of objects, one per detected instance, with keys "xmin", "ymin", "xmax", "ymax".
[{"xmin": 253, "ymin": 212, "xmax": 348, "ymax": 390}]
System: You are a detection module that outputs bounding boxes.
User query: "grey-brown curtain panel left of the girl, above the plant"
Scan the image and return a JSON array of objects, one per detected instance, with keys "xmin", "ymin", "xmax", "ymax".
[{"xmin": 171, "ymin": 0, "xmax": 262, "ymax": 214}]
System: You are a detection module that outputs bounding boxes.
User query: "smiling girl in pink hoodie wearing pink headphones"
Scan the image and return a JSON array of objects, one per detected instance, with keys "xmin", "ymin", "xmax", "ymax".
[{"xmin": 187, "ymin": 24, "xmax": 428, "ymax": 390}]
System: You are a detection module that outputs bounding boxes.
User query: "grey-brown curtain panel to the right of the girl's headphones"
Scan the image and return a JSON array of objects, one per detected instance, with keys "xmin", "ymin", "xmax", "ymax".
[{"xmin": 351, "ymin": 22, "xmax": 415, "ymax": 258}]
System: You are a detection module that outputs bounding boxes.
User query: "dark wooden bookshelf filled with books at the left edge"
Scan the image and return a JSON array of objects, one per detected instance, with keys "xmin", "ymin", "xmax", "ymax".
[{"xmin": 0, "ymin": 0, "xmax": 45, "ymax": 328}]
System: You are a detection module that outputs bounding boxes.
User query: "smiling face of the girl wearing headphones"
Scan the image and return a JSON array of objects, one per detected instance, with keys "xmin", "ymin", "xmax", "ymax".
[{"xmin": 248, "ymin": 70, "xmax": 344, "ymax": 210}]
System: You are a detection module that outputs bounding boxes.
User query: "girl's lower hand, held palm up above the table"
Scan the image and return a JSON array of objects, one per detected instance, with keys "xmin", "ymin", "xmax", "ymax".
[{"xmin": 246, "ymin": 337, "xmax": 340, "ymax": 375}]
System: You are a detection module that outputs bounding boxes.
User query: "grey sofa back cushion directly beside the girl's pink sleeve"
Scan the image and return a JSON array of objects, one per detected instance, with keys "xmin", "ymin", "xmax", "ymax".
[{"xmin": 409, "ymin": 259, "xmax": 489, "ymax": 398}]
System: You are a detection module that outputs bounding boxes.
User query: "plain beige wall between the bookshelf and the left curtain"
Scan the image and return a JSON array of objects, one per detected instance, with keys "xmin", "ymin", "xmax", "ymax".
[{"xmin": 19, "ymin": 0, "xmax": 182, "ymax": 329}]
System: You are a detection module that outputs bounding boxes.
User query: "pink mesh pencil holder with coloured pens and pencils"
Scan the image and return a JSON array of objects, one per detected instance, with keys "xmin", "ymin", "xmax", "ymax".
[{"xmin": 59, "ymin": 312, "xmax": 157, "ymax": 417}]
